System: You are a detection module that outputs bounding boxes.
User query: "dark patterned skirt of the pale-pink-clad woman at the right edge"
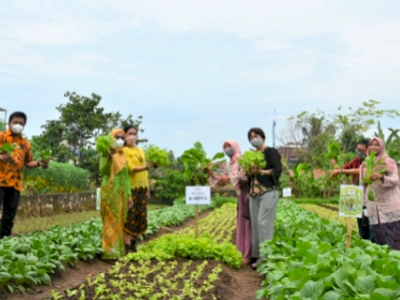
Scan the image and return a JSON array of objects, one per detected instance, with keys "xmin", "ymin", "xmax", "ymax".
[{"xmin": 372, "ymin": 221, "xmax": 400, "ymax": 250}]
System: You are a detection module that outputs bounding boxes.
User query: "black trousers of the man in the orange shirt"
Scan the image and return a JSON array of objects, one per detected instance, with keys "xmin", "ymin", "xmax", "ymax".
[{"xmin": 0, "ymin": 186, "xmax": 21, "ymax": 239}]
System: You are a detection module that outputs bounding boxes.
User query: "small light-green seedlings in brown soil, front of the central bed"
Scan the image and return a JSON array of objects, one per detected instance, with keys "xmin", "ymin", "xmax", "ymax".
[{"xmin": 53, "ymin": 259, "xmax": 232, "ymax": 300}]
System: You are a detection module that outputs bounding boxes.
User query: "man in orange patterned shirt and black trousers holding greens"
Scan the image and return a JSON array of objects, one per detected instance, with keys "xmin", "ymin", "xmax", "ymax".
[{"xmin": 0, "ymin": 111, "xmax": 47, "ymax": 239}]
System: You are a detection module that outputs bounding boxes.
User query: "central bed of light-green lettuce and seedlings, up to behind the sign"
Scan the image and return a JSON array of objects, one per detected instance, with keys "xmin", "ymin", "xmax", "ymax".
[{"xmin": 49, "ymin": 204, "xmax": 244, "ymax": 299}]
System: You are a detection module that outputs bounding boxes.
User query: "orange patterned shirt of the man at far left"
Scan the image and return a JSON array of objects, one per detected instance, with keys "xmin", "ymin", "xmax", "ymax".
[{"xmin": 0, "ymin": 129, "xmax": 33, "ymax": 192}]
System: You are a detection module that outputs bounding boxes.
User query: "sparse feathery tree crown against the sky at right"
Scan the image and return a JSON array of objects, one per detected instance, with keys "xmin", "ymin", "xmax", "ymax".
[{"xmin": 286, "ymin": 100, "xmax": 400, "ymax": 168}]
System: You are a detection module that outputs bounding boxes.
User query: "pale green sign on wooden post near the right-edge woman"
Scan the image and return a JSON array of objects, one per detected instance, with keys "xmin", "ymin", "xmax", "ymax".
[{"xmin": 339, "ymin": 184, "xmax": 364, "ymax": 249}]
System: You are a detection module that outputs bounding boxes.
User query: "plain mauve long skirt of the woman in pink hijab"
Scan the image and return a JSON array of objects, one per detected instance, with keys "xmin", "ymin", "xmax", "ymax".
[{"xmin": 236, "ymin": 187, "xmax": 252, "ymax": 259}]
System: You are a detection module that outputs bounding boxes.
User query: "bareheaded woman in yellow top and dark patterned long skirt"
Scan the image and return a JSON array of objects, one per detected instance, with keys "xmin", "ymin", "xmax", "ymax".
[{"xmin": 124, "ymin": 125, "xmax": 154, "ymax": 252}]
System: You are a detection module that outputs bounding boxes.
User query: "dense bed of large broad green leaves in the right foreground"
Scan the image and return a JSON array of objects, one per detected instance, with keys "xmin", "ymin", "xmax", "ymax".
[{"xmin": 257, "ymin": 203, "xmax": 400, "ymax": 300}]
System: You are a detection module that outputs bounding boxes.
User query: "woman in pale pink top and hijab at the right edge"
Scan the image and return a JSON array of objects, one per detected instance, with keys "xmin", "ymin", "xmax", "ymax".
[{"xmin": 361, "ymin": 137, "xmax": 400, "ymax": 250}]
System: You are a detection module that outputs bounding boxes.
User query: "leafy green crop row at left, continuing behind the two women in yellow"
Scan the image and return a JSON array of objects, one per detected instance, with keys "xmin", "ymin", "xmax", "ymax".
[{"xmin": 0, "ymin": 199, "xmax": 228, "ymax": 292}]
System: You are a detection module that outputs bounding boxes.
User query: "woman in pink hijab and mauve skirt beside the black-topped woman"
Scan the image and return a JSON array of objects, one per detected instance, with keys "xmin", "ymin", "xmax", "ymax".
[{"xmin": 205, "ymin": 140, "xmax": 252, "ymax": 265}]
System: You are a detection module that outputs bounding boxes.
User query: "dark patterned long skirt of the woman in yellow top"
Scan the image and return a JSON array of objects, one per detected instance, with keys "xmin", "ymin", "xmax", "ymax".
[{"xmin": 124, "ymin": 187, "xmax": 148, "ymax": 238}]
